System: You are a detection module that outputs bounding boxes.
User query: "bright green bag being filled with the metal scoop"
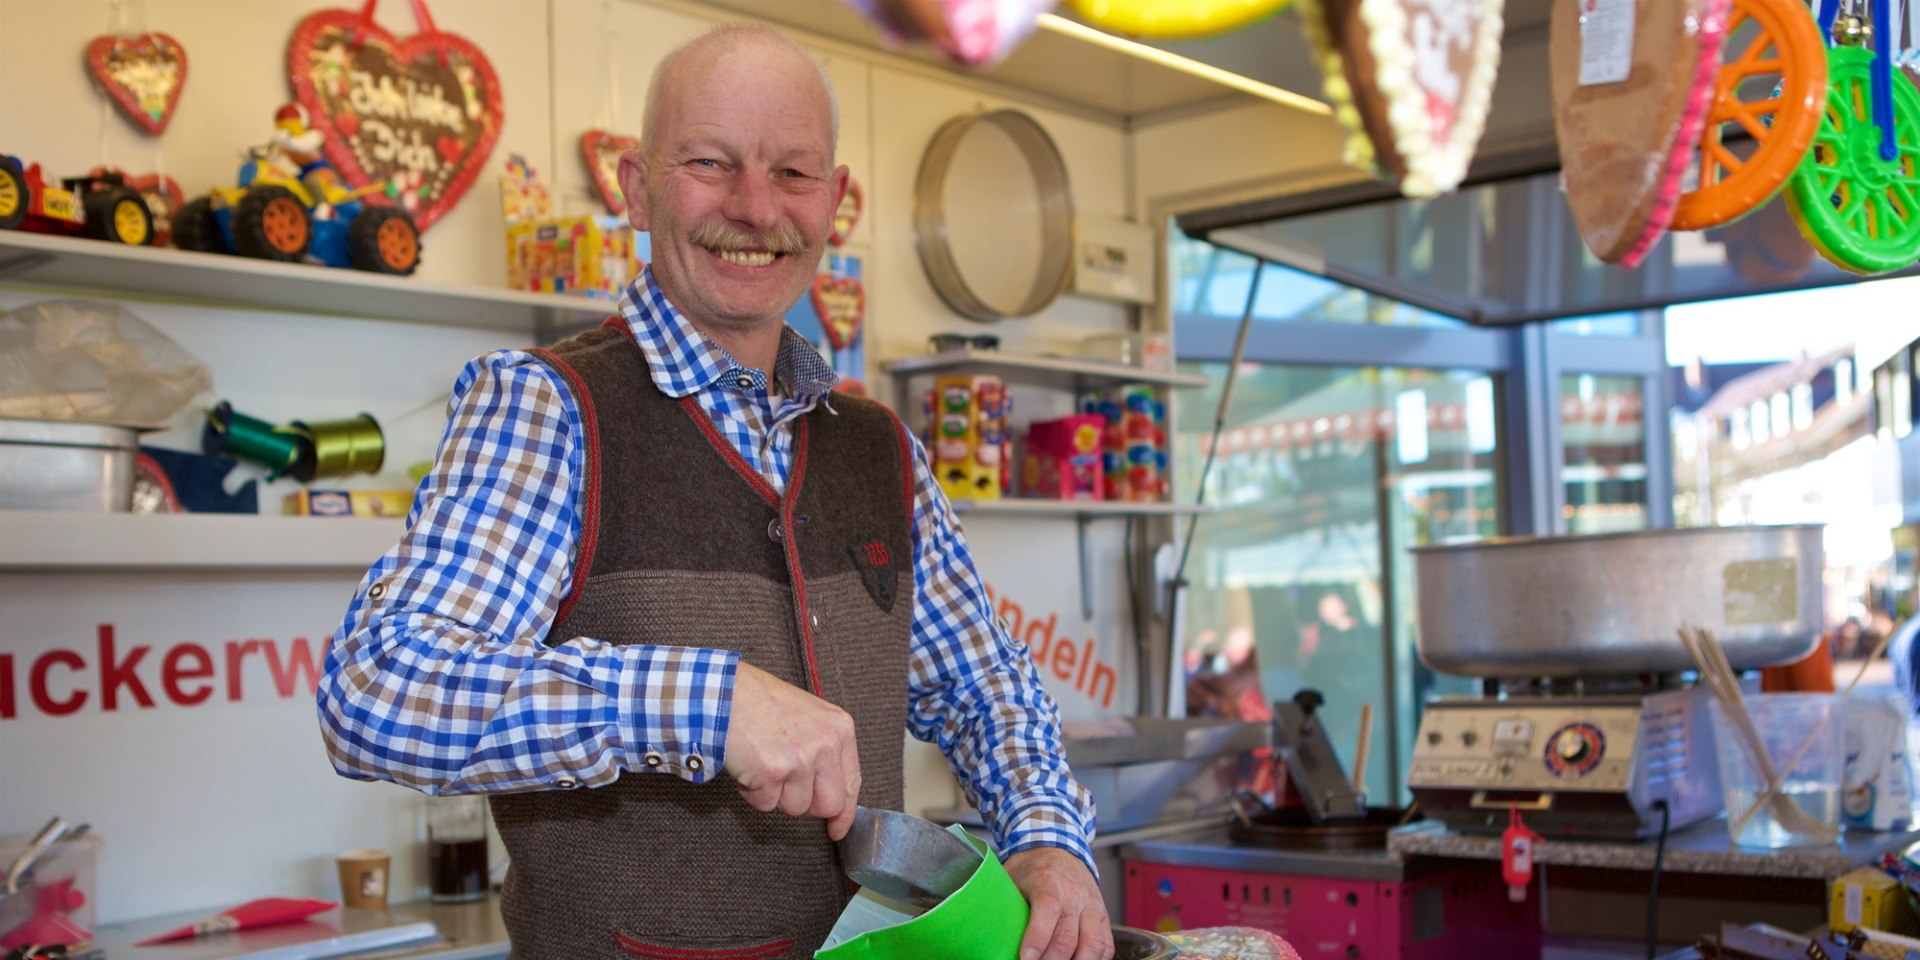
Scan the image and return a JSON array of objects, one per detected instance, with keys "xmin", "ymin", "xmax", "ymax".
[{"xmin": 814, "ymin": 826, "xmax": 1027, "ymax": 960}]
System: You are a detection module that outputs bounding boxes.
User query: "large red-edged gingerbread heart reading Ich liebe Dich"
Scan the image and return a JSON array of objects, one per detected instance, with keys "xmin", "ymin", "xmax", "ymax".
[{"xmin": 286, "ymin": 10, "xmax": 505, "ymax": 230}]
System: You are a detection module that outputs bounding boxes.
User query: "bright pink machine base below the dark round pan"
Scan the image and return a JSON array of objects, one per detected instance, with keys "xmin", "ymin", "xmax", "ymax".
[{"xmin": 1123, "ymin": 860, "xmax": 1542, "ymax": 960}]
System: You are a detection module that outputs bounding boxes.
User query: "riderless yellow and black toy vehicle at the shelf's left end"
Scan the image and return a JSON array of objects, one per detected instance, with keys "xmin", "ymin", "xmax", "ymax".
[{"xmin": 0, "ymin": 154, "xmax": 154, "ymax": 246}]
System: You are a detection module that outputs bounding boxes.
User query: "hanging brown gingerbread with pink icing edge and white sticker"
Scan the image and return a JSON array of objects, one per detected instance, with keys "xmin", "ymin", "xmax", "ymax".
[{"xmin": 1548, "ymin": 0, "xmax": 1732, "ymax": 267}]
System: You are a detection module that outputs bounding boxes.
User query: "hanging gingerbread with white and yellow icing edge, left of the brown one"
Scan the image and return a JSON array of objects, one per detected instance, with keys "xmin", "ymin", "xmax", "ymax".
[{"xmin": 1296, "ymin": 0, "xmax": 1503, "ymax": 198}]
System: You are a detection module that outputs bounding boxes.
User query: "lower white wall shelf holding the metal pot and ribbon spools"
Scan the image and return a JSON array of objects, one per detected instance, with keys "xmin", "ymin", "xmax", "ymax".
[{"xmin": 0, "ymin": 511, "xmax": 403, "ymax": 574}]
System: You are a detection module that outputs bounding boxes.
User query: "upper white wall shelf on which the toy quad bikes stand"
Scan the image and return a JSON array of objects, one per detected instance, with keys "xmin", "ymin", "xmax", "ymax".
[{"xmin": 0, "ymin": 230, "xmax": 612, "ymax": 336}]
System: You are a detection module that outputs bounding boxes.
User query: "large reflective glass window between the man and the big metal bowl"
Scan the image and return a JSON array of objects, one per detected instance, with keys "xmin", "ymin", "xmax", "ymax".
[{"xmin": 1173, "ymin": 363, "xmax": 1501, "ymax": 804}]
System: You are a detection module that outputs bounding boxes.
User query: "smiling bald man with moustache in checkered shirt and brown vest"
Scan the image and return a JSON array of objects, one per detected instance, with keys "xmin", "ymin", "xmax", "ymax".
[{"xmin": 319, "ymin": 25, "xmax": 1114, "ymax": 960}]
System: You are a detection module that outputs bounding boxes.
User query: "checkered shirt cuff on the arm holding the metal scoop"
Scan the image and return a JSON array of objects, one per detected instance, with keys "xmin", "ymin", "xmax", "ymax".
[{"xmin": 612, "ymin": 645, "xmax": 739, "ymax": 783}]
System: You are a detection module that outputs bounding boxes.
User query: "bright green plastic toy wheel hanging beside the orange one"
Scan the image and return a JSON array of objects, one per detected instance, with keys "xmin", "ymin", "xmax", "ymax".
[{"xmin": 1788, "ymin": 46, "xmax": 1920, "ymax": 273}]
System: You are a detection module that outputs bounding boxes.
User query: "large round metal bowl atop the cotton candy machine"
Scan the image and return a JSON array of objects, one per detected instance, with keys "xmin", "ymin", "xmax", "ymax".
[{"xmin": 1413, "ymin": 524, "xmax": 1824, "ymax": 678}]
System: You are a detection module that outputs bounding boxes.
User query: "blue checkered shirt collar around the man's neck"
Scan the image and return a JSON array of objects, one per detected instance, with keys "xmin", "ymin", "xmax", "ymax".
[{"xmin": 620, "ymin": 267, "xmax": 839, "ymax": 401}]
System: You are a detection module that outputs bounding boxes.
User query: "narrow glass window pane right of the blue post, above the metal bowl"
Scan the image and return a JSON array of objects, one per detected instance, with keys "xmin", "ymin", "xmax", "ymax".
[{"xmin": 1561, "ymin": 372, "xmax": 1651, "ymax": 534}]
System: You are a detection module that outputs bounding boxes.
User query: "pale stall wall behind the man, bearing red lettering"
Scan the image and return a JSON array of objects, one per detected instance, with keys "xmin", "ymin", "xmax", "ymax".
[{"xmin": 0, "ymin": 0, "xmax": 1173, "ymax": 922}]
